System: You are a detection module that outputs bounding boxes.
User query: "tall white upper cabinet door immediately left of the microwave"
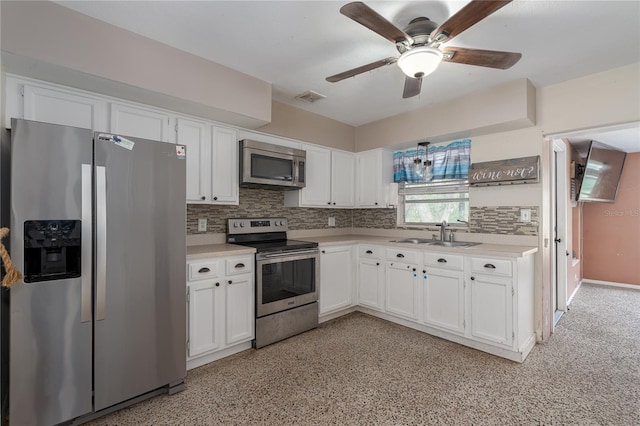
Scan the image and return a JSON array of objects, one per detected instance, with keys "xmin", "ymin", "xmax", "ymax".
[{"xmin": 210, "ymin": 127, "xmax": 239, "ymax": 204}]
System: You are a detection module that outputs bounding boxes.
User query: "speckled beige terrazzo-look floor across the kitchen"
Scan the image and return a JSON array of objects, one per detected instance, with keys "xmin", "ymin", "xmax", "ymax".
[{"xmin": 86, "ymin": 285, "xmax": 640, "ymax": 426}]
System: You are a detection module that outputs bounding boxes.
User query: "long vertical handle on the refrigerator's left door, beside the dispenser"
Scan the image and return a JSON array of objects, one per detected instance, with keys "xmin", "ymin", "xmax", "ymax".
[{"xmin": 80, "ymin": 164, "xmax": 92, "ymax": 322}]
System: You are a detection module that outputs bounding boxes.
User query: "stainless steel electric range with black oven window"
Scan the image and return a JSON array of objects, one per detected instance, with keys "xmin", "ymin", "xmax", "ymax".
[{"xmin": 227, "ymin": 218, "xmax": 319, "ymax": 348}]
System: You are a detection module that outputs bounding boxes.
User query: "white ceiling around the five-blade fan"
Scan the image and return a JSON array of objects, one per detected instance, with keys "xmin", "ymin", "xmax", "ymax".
[{"xmin": 56, "ymin": 0, "xmax": 640, "ymax": 151}]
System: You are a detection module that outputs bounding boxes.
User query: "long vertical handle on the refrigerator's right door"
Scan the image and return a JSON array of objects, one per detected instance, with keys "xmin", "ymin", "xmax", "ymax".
[{"xmin": 96, "ymin": 166, "xmax": 107, "ymax": 321}]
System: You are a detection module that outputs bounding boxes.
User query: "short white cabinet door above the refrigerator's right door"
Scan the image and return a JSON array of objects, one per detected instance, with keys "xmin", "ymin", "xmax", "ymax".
[{"xmin": 111, "ymin": 103, "xmax": 170, "ymax": 142}]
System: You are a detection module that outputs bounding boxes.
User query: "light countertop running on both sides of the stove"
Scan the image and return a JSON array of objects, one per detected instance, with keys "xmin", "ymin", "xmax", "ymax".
[{"xmin": 187, "ymin": 234, "xmax": 538, "ymax": 260}]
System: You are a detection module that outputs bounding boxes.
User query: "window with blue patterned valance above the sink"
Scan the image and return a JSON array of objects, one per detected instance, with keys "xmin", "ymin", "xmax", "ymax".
[{"xmin": 394, "ymin": 139, "xmax": 471, "ymax": 226}]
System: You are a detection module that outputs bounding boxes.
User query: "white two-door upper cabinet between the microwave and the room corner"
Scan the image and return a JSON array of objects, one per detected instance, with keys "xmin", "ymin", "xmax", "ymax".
[{"xmin": 284, "ymin": 143, "xmax": 355, "ymax": 207}]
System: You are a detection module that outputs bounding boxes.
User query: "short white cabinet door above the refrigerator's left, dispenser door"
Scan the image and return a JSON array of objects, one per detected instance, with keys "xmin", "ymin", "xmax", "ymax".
[{"xmin": 23, "ymin": 85, "xmax": 107, "ymax": 131}]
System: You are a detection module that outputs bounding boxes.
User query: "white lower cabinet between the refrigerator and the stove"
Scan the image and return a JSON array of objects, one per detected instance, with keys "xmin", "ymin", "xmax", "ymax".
[{"xmin": 187, "ymin": 256, "xmax": 254, "ymax": 369}]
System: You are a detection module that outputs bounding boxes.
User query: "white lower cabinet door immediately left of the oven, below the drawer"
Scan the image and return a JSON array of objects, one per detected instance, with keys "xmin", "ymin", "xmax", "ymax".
[{"xmin": 225, "ymin": 274, "xmax": 255, "ymax": 345}]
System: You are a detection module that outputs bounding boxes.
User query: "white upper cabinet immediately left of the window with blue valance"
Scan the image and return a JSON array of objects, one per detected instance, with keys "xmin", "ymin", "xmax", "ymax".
[{"xmin": 356, "ymin": 149, "xmax": 393, "ymax": 208}]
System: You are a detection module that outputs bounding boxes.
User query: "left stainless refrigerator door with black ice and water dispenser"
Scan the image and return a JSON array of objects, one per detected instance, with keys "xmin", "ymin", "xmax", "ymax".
[{"xmin": 7, "ymin": 120, "xmax": 92, "ymax": 425}]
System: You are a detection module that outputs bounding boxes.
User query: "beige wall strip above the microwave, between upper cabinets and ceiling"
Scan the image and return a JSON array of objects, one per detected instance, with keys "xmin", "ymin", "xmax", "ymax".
[{"xmin": 257, "ymin": 101, "xmax": 355, "ymax": 151}]
